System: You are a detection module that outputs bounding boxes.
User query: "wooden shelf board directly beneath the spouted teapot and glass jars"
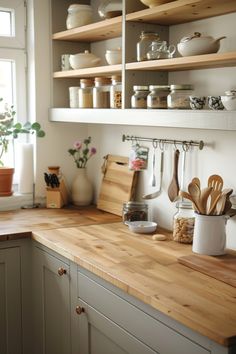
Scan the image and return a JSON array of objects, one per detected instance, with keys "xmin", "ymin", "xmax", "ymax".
[{"xmin": 125, "ymin": 51, "xmax": 236, "ymax": 71}]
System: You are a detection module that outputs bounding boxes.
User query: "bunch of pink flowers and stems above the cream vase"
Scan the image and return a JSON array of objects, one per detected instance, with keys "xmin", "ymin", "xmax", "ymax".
[{"xmin": 68, "ymin": 136, "xmax": 97, "ymax": 168}]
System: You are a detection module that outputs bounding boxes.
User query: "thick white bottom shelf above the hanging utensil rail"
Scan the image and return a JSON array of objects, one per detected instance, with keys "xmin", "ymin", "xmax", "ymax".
[{"xmin": 50, "ymin": 108, "xmax": 236, "ymax": 131}]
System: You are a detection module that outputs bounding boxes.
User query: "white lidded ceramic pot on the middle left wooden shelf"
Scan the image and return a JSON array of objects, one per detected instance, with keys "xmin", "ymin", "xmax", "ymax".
[{"xmin": 69, "ymin": 50, "xmax": 101, "ymax": 69}]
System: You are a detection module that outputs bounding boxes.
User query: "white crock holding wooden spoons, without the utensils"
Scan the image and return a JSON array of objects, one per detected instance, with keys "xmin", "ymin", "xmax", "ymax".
[{"xmin": 192, "ymin": 213, "xmax": 227, "ymax": 256}]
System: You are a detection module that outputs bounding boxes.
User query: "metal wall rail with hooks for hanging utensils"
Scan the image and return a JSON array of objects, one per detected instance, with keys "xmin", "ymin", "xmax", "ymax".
[{"xmin": 122, "ymin": 134, "xmax": 204, "ymax": 150}]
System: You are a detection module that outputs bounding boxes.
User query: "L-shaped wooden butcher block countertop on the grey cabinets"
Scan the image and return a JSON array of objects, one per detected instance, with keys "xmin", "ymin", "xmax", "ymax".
[{"xmin": 0, "ymin": 208, "xmax": 236, "ymax": 346}]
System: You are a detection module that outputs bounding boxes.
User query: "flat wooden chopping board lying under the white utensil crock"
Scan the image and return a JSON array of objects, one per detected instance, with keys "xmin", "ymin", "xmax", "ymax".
[{"xmin": 178, "ymin": 251, "xmax": 236, "ymax": 287}]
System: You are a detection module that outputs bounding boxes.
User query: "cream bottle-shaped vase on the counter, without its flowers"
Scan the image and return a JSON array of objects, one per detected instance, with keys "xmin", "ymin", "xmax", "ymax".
[{"xmin": 71, "ymin": 168, "xmax": 93, "ymax": 206}]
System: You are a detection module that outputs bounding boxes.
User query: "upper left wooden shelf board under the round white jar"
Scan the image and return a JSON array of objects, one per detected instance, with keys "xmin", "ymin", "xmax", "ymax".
[{"xmin": 52, "ymin": 16, "xmax": 122, "ymax": 42}]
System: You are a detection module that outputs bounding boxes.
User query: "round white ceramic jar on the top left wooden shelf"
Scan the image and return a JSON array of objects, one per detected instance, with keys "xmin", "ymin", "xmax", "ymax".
[{"xmin": 66, "ymin": 4, "xmax": 92, "ymax": 29}]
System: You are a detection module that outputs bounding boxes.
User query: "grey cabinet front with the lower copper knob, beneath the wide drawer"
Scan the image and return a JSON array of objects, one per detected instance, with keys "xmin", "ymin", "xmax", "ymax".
[{"xmin": 78, "ymin": 299, "xmax": 157, "ymax": 354}]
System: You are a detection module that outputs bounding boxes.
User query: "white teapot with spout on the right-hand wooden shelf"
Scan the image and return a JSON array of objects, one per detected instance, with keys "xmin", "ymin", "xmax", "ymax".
[{"xmin": 177, "ymin": 32, "xmax": 226, "ymax": 57}]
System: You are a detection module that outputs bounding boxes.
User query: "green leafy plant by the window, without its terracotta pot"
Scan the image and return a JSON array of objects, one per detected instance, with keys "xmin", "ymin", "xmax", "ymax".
[{"xmin": 0, "ymin": 98, "xmax": 45, "ymax": 166}]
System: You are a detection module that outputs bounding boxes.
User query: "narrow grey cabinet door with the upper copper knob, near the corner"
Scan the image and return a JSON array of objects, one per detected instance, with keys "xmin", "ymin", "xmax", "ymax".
[{"xmin": 33, "ymin": 247, "xmax": 71, "ymax": 354}]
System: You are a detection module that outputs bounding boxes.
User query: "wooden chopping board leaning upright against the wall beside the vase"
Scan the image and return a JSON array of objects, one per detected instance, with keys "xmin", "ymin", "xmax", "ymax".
[{"xmin": 97, "ymin": 155, "xmax": 138, "ymax": 216}]
